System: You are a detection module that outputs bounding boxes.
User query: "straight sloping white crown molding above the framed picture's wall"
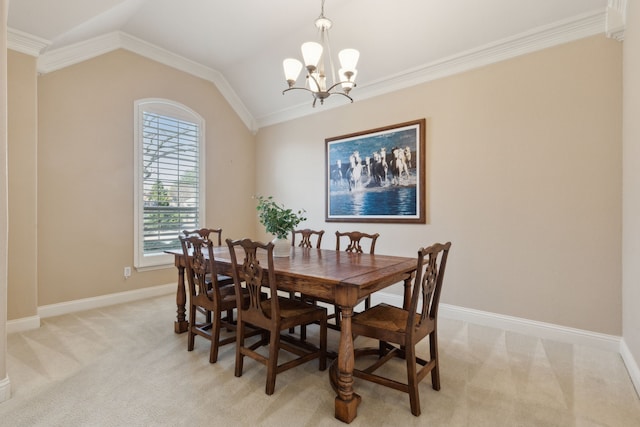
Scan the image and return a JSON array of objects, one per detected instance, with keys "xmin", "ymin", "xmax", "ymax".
[{"xmin": 257, "ymin": 9, "xmax": 604, "ymax": 128}]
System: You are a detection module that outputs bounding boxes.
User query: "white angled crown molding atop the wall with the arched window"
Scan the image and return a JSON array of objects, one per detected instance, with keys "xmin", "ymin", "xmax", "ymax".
[{"xmin": 38, "ymin": 31, "xmax": 258, "ymax": 134}]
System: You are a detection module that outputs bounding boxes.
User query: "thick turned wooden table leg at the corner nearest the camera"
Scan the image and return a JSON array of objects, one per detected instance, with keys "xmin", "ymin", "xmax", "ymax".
[{"xmin": 335, "ymin": 307, "xmax": 361, "ymax": 423}]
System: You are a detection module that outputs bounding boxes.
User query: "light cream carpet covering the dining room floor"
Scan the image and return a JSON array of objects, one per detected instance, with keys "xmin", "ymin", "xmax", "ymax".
[{"xmin": 0, "ymin": 295, "xmax": 640, "ymax": 427}]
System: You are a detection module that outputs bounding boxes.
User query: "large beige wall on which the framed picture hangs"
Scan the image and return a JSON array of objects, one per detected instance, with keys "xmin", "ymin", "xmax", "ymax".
[{"xmin": 256, "ymin": 35, "xmax": 622, "ymax": 335}]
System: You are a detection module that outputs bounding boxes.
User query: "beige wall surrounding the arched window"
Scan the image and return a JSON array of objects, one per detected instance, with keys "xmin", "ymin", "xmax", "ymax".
[{"xmin": 29, "ymin": 50, "xmax": 255, "ymax": 306}]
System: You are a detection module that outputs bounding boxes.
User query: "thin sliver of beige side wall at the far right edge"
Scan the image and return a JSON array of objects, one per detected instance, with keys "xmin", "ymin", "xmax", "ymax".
[{"xmin": 622, "ymin": 5, "xmax": 640, "ymax": 368}]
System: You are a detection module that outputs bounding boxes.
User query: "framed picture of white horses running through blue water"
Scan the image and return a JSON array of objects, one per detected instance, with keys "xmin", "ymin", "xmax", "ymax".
[{"xmin": 325, "ymin": 119, "xmax": 426, "ymax": 224}]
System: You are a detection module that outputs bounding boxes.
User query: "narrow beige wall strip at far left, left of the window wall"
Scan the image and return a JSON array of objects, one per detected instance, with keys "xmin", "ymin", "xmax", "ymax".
[{"xmin": 7, "ymin": 50, "xmax": 38, "ymax": 319}]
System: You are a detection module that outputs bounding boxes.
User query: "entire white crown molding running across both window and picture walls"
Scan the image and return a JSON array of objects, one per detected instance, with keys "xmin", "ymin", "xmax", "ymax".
[{"xmin": 10, "ymin": 7, "xmax": 608, "ymax": 134}]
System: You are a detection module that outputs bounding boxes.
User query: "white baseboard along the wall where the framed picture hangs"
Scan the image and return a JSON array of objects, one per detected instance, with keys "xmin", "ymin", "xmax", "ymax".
[{"xmin": 374, "ymin": 292, "xmax": 621, "ymax": 353}]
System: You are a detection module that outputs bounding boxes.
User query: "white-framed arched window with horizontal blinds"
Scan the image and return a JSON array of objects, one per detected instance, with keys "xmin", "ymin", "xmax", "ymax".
[{"xmin": 134, "ymin": 99, "xmax": 205, "ymax": 269}]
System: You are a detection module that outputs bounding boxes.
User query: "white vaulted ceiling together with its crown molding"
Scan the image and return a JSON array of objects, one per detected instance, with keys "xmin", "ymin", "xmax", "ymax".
[{"xmin": 8, "ymin": 0, "xmax": 612, "ymax": 130}]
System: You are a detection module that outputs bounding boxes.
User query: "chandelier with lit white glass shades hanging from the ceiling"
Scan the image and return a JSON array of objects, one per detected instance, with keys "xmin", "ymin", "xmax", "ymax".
[{"xmin": 282, "ymin": 0, "xmax": 360, "ymax": 107}]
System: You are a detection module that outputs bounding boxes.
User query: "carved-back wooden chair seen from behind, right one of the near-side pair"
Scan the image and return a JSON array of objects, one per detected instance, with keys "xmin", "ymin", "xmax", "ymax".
[{"xmin": 226, "ymin": 239, "xmax": 327, "ymax": 395}]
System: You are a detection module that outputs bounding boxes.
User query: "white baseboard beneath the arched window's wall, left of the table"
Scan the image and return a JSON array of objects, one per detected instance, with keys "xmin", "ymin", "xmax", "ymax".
[{"xmin": 38, "ymin": 283, "xmax": 176, "ymax": 318}]
